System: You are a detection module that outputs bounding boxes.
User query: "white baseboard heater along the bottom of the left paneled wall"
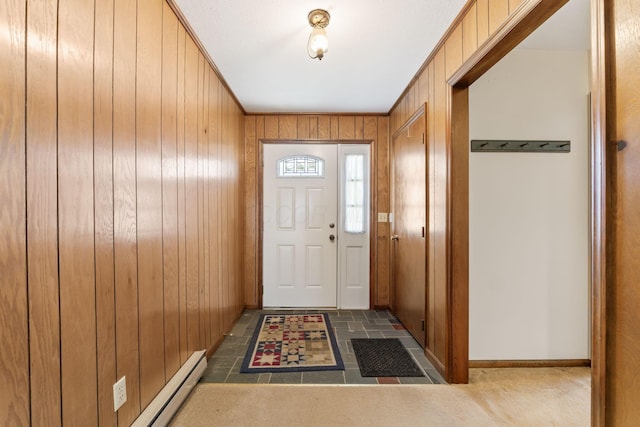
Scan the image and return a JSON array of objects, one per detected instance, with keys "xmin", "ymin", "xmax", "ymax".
[{"xmin": 132, "ymin": 350, "xmax": 207, "ymax": 427}]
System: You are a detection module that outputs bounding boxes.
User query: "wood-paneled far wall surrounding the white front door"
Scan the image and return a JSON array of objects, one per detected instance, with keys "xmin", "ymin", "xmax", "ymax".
[{"xmin": 244, "ymin": 114, "xmax": 390, "ymax": 307}]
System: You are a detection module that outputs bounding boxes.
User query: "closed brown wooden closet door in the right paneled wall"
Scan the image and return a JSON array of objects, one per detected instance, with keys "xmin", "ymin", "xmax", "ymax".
[{"xmin": 392, "ymin": 115, "xmax": 427, "ymax": 347}]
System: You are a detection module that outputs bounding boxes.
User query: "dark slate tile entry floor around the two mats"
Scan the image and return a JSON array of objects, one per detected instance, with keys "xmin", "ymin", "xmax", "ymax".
[{"xmin": 200, "ymin": 310, "xmax": 445, "ymax": 384}]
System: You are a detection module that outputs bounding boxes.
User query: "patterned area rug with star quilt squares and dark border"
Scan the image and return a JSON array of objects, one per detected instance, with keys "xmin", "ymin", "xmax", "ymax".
[{"xmin": 240, "ymin": 313, "xmax": 344, "ymax": 373}]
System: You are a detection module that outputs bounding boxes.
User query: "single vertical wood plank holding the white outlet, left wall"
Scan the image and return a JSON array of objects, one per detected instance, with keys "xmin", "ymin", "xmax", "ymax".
[{"xmin": 112, "ymin": 0, "xmax": 141, "ymax": 425}]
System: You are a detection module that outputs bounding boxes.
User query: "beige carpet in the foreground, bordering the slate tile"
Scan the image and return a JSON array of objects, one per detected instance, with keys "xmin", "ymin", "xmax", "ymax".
[{"xmin": 172, "ymin": 368, "xmax": 590, "ymax": 427}]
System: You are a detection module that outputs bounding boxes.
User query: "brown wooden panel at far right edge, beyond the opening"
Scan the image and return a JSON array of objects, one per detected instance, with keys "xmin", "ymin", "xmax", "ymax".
[{"xmin": 606, "ymin": 0, "xmax": 640, "ymax": 426}]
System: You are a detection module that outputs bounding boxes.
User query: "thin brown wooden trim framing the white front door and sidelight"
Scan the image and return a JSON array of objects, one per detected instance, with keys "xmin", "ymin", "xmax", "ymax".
[{"xmin": 256, "ymin": 139, "xmax": 377, "ymax": 309}]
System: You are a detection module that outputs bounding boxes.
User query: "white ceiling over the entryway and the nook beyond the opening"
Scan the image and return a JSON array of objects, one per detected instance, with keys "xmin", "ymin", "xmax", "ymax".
[{"xmin": 175, "ymin": 0, "xmax": 589, "ymax": 113}]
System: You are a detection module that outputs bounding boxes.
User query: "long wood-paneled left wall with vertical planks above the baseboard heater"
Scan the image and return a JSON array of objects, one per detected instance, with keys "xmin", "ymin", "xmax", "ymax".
[{"xmin": 0, "ymin": 0, "xmax": 244, "ymax": 425}]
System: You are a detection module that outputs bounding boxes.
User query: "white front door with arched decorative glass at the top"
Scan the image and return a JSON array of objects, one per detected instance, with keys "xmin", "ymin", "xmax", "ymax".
[{"xmin": 262, "ymin": 144, "xmax": 338, "ymax": 307}]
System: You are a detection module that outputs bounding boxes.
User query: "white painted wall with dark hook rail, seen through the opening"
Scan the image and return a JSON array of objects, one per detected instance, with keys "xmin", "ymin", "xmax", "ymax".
[{"xmin": 469, "ymin": 50, "xmax": 590, "ymax": 360}]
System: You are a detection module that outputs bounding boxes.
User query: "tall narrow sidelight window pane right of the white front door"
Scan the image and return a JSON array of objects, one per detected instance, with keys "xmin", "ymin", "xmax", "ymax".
[{"xmin": 344, "ymin": 154, "xmax": 365, "ymax": 234}]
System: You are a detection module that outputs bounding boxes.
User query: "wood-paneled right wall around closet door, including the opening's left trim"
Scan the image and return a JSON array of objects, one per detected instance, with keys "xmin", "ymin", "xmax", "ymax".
[{"xmin": 390, "ymin": 0, "xmax": 566, "ymax": 382}]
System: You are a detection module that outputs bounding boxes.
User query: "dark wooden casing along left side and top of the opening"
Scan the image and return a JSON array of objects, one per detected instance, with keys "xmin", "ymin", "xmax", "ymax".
[{"xmin": 444, "ymin": 1, "xmax": 593, "ymax": 383}]
